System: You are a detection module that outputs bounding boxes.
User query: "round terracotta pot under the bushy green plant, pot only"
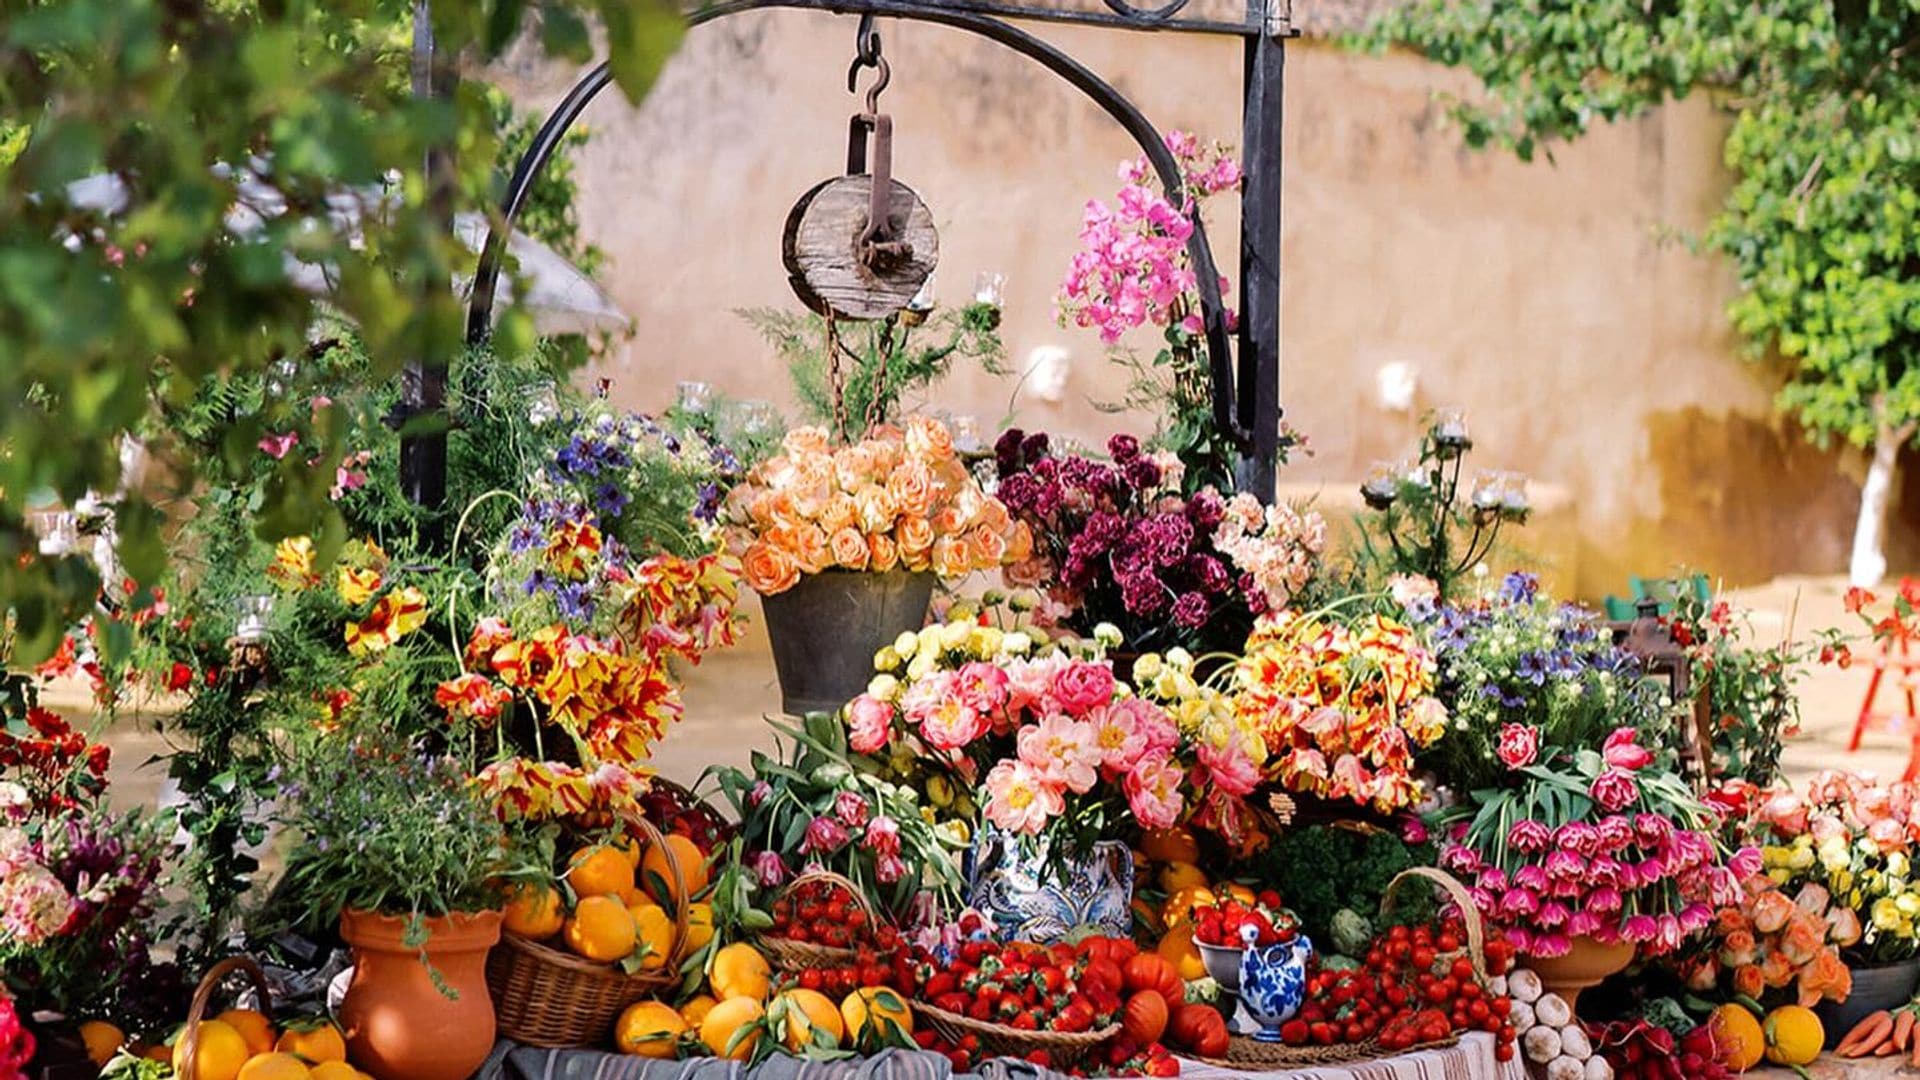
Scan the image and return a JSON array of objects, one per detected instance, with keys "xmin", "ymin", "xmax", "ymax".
[{"xmin": 340, "ymin": 911, "xmax": 501, "ymax": 1080}]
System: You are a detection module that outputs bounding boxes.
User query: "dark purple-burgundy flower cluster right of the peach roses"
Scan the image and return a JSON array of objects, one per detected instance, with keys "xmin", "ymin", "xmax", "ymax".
[{"xmin": 995, "ymin": 429, "xmax": 1258, "ymax": 650}]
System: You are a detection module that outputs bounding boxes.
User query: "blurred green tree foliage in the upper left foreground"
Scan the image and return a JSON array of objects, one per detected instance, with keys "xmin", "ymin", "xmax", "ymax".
[{"xmin": 0, "ymin": 0, "xmax": 682, "ymax": 661}]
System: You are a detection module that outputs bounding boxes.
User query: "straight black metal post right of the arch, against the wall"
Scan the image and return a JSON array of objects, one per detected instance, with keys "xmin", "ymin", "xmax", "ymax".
[{"xmin": 1236, "ymin": 0, "xmax": 1292, "ymax": 502}]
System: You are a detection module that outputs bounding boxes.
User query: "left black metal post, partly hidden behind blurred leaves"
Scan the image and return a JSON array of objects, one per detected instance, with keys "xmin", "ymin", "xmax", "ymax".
[{"xmin": 399, "ymin": 0, "xmax": 457, "ymax": 511}]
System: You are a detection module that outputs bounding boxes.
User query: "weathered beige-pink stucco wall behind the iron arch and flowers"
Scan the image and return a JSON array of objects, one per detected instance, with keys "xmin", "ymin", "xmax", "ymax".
[{"xmin": 483, "ymin": 12, "xmax": 1853, "ymax": 594}]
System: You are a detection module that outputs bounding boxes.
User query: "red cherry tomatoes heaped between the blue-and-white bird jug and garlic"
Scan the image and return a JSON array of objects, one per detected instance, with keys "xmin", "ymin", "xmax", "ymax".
[{"xmin": 1281, "ymin": 920, "xmax": 1515, "ymax": 1061}]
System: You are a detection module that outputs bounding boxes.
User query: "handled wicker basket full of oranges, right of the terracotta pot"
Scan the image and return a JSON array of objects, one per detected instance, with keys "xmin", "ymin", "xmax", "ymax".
[{"xmin": 488, "ymin": 815, "xmax": 712, "ymax": 1047}]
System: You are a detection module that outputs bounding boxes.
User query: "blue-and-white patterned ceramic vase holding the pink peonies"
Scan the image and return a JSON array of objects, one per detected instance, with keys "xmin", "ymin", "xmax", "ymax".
[{"xmin": 966, "ymin": 828, "xmax": 1133, "ymax": 944}]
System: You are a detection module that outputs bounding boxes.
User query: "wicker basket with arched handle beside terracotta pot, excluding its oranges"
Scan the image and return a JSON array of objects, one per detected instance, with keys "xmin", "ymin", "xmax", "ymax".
[{"xmin": 486, "ymin": 815, "xmax": 687, "ymax": 1049}]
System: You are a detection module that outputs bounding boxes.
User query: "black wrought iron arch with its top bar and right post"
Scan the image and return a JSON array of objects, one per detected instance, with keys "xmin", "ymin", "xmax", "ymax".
[{"xmin": 443, "ymin": 0, "xmax": 1292, "ymax": 498}]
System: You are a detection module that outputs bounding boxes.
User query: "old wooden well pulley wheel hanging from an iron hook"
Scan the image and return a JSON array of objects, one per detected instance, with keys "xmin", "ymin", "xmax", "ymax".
[{"xmin": 781, "ymin": 15, "xmax": 941, "ymax": 319}]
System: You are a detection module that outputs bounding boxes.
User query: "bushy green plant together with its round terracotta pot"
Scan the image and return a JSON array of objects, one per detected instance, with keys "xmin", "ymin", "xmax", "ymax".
[{"xmin": 280, "ymin": 732, "xmax": 511, "ymax": 1080}]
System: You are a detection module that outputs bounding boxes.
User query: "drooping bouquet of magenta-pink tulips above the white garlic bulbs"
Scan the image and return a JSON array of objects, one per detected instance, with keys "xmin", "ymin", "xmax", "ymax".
[{"xmin": 1440, "ymin": 728, "xmax": 1761, "ymax": 957}]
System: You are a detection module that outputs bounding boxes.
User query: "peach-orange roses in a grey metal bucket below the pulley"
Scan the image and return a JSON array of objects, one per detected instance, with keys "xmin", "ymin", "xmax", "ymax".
[{"xmin": 722, "ymin": 417, "xmax": 1031, "ymax": 715}]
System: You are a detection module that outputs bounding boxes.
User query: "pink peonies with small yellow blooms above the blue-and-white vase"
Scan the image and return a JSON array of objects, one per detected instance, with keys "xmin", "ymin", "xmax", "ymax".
[{"xmin": 843, "ymin": 621, "xmax": 1258, "ymax": 849}]
